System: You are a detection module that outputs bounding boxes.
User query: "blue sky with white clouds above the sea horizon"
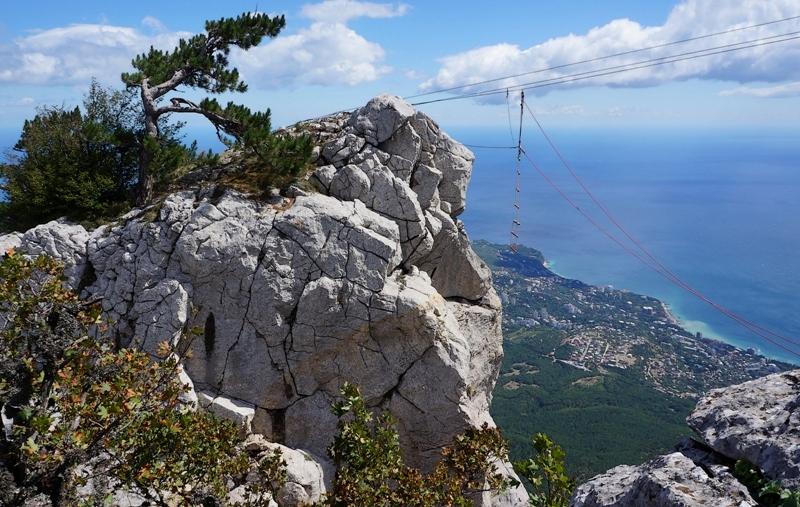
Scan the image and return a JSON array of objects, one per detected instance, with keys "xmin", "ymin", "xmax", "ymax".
[{"xmin": 0, "ymin": 0, "xmax": 800, "ymax": 137}]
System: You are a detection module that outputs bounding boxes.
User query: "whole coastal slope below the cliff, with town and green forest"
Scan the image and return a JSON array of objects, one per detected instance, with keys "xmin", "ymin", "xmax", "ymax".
[{"xmin": 473, "ymin": 241, "xmax": 792, "ymax": 482}]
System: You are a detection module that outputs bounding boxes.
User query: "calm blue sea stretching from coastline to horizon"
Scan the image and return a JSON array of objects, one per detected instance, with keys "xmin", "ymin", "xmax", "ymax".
[{"xmin": 0, "ymin": 126, "xmax": 800, "ymax": 364}]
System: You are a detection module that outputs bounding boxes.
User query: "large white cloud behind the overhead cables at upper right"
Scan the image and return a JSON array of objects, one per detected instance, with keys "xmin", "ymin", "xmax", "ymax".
[{"xmin": 420, "ymin": 0, "xmax": 800, "ymax": 100}]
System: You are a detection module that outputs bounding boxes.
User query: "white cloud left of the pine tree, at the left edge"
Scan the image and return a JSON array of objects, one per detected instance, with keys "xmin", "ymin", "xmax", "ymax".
[{"xmin": 0, "ymin": 22, "xmax": 191, "ymax": 85}]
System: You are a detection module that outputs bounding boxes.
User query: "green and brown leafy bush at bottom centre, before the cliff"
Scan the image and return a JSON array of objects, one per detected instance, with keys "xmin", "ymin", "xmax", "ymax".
[{"xmin": 323, "ymin": 383, "xmax": 512, "ymax": 507}]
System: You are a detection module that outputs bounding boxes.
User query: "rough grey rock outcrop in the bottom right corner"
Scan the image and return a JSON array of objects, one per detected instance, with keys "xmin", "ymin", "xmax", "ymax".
[{"xmin": 570, "ymin": 370, "xmax": 800, "ymax": 507}]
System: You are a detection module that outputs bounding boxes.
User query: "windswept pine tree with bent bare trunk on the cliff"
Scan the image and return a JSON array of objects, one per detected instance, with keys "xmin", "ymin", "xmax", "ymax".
[{"xmin": 122, "ymin": 13, "xmax": 312, "ymax": 206}]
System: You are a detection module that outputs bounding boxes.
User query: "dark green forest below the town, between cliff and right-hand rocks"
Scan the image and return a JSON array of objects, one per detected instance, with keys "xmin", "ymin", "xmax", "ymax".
[{"xmin": 491, "ymin": 330, "xmax": 695, "ymax": 482}]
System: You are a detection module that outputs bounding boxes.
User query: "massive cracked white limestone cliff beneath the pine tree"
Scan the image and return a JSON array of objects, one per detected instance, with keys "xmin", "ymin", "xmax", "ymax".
[{"xmin": 7, "ymin": 95, "xmax": 527, "ymax": 505}]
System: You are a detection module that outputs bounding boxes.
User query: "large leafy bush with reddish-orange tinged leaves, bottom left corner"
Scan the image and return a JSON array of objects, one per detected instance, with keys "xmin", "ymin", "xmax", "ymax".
[{"xmin": 0, "ymin": 250, "xmax": 284, "ymax": 506}]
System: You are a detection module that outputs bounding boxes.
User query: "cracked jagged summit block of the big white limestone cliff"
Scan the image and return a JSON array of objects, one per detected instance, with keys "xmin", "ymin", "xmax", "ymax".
[{"xmin": 313, "ymin": 96, "xmax": 491, "ymax": 301}]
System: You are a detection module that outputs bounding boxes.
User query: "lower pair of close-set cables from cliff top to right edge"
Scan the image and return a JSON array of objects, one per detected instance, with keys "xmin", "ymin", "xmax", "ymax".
[{"xmin": 411, "ymin": 31, "xmax": 800, "ymax": 106}]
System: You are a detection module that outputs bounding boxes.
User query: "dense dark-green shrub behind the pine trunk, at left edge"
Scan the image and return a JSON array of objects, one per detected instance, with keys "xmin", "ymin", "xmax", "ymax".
[{"xmin": 0, "ymin": 82, "xmax": 195, "ymax": 231}]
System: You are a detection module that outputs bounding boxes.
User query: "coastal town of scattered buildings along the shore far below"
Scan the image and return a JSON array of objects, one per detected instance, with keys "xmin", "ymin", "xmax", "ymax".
[{"xmin": 476, "ymin": 242, "xmax": 794, "ymax": 399}]
